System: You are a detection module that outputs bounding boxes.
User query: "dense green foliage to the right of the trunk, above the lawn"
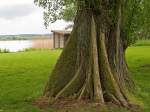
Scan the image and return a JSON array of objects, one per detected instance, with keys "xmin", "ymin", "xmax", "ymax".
[{"xmin": 123, "ymin": 0, "xmax": 150, "ymax": 44}]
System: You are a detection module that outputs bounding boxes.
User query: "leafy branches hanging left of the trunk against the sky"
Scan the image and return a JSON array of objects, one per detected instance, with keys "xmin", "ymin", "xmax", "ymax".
[{"xmin": 34, "ymin": 0, "xmax": 76, "ymax": 27}]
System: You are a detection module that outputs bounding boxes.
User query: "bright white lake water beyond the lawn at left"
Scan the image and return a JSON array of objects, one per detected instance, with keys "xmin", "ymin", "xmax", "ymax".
[{"xmin": 0, "ymin": 40, "xmax": 33, "ymax": 52}]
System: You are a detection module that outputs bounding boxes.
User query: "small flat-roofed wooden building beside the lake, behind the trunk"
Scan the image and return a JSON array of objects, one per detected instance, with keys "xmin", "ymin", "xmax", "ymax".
[{"xmin": 52, "ymin": 30, "xmax": 71, "ymax": 49}]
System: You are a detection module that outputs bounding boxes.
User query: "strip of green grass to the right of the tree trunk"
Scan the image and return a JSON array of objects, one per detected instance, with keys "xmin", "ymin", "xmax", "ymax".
[{"xmin": 126, "ymin": 46, "xmax": 150, "ymax": 112}]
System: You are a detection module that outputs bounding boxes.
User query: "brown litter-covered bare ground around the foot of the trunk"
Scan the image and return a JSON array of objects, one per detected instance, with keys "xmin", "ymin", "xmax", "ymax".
[{"xmin": 32, "ymin": 97, "xmax": 143, "ymax": 112}]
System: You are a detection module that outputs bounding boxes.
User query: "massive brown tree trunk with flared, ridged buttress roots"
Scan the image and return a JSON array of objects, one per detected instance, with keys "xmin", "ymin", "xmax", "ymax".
[{"xmin": 44, "ymin": 0, "xmax": 134, "ymax": 107}]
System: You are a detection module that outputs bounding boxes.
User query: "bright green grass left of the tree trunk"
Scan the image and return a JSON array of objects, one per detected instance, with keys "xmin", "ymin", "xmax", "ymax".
[{"xmin": 0, "ymin": 51, "xmax": 60, "ymax": 112}]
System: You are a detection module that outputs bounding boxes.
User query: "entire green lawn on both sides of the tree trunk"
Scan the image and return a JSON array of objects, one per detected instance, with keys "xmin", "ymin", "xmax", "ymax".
[{"xmin": 0, "ymin": 46, "xmax": 150, "ymax": 112}]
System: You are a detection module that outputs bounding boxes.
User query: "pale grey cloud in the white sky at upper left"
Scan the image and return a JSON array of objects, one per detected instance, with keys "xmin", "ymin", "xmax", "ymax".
[{"xmin": 0, "ymin": 4, "xmax": 36, "ymax": 20}]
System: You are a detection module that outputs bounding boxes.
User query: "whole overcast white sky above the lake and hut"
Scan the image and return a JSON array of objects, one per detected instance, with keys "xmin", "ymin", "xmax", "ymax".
[{"xmin": 0, "ymin": 0, "xmax": 71, "ymax": 35}]
